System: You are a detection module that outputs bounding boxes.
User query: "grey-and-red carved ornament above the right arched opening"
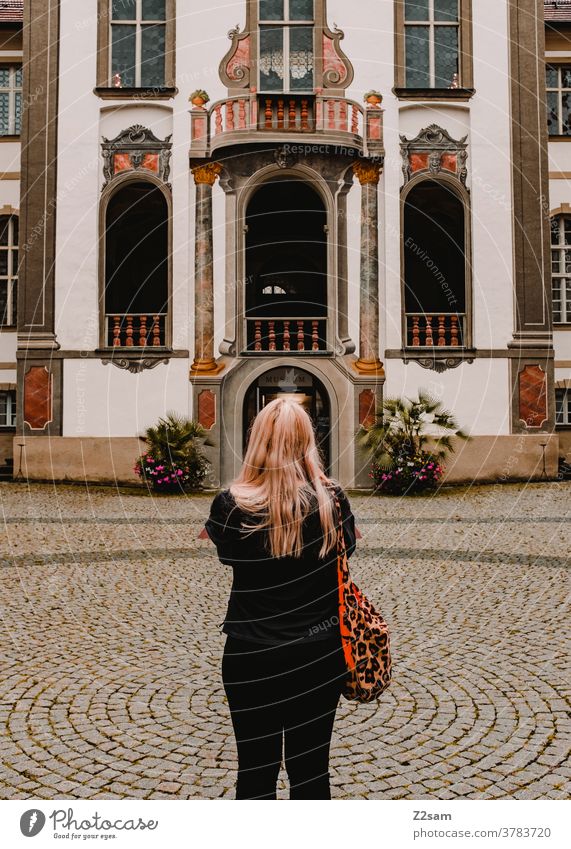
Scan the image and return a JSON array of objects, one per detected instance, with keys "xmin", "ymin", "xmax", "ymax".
[{"xmin": 400, "ymin": 124, "xmax": 468, "ymax": 186}]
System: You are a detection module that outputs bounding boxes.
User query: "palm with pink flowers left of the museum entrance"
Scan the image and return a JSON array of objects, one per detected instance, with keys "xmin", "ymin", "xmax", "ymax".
[{"xmin": 134, "ymin": 412, "xmax": 214, "ymax": 493}]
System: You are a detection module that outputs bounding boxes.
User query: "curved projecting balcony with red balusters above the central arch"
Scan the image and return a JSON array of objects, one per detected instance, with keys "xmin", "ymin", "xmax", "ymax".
[{"xmin": 190, "ymin": 94, "xmax": 383, "ymax": 158}]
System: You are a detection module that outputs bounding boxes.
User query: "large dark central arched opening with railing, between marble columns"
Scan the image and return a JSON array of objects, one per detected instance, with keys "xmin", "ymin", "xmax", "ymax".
[{"xmin": 245, "ymin": 177, "xmax": 327, "ymax": 352}]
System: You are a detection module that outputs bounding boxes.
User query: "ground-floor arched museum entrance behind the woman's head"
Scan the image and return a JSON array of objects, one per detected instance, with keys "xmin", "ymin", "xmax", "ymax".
[{"xmin": 242, "ymin": 366, "xmax": 331, "ymax": 474}]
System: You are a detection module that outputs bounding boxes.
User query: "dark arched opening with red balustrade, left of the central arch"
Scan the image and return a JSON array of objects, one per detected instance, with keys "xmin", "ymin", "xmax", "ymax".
[{"xmin": 104, "ymin": 181, "xmax": 169, "ymax": 347}]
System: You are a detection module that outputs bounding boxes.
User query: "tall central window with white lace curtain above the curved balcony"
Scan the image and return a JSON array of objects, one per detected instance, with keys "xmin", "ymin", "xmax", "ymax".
[{"xmin": 259, "ymin": 0, "xmax": 314, "ymax": 92}]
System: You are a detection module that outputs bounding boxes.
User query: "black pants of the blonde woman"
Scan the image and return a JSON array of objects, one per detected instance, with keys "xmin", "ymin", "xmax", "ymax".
[{"xmin": 222, "ymin": 636, "xmax": 345, "ymax": 799}]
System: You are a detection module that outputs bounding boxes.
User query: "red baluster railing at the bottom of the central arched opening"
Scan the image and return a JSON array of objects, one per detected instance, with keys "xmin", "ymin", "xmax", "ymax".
[{"xmin": 246, "ymin": 316, "xmax": 327, "ymax": 354}]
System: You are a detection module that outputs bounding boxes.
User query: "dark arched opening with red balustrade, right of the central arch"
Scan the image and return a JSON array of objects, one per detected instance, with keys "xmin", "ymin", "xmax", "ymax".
[{"xmin": 403, "ymin": 179, "xmax": 468, "ymax": 347}]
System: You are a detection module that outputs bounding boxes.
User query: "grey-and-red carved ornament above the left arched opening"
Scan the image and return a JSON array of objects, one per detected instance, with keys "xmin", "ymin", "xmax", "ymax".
[{"xmin": 101, "ymin": 124, "xmax": 172, "ymax": 189}]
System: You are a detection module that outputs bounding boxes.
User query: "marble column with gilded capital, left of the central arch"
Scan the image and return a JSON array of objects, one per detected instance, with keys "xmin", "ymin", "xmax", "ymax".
[{"xmin": 190, "ymin": 162, "xmax": 224, "ymax": 375}]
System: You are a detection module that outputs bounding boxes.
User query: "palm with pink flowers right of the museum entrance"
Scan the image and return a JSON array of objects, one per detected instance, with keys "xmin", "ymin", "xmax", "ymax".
[{"xmin": 356, "ymin": 389, "xmax": 472, "ymax": 495}]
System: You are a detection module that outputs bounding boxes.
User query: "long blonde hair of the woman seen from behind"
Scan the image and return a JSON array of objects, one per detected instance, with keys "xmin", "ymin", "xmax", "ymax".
[{"xmin": 229, "ymin": 397, "xmax": 337, "ymax": 558}]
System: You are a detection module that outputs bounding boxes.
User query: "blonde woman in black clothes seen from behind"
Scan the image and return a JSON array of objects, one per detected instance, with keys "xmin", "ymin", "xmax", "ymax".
[{"xmin": 206, "ymin": 398, "xmax": 355, "ymax": 799}]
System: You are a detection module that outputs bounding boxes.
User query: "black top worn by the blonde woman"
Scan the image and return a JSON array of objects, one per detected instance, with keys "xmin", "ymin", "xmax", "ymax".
[{"xmin": 205, "ymin": 484, "xmax": 356, "ymax": 645}]
